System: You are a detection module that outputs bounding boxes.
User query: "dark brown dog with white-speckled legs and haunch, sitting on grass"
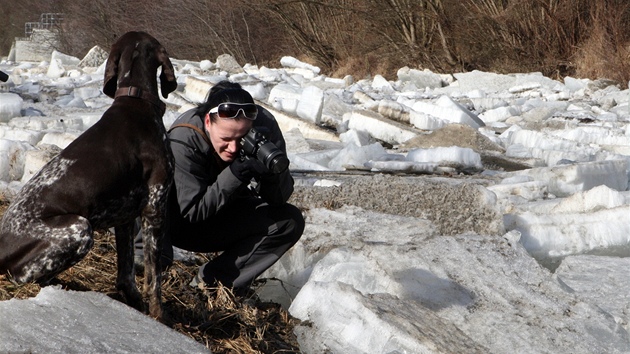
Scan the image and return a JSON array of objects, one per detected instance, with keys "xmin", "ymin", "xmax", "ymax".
[{"xmin": 0, "ymin": 32, "xmax": 177, "ymax": 318}]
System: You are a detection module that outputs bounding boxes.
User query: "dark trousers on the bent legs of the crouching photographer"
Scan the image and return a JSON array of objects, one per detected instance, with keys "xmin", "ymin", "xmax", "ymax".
[{"xmin": 169, "ymin": 198, "xmax": 305, "ymax": 289}]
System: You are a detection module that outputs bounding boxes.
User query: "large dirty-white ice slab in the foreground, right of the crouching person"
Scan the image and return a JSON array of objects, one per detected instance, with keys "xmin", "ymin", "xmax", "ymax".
[{"xmin": 280, "ymin": 208, "xmax": 629, "ymax": 353}]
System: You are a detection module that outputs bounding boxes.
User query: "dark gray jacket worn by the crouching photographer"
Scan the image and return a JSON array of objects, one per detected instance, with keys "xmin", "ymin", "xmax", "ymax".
[{"xmin": 168, "ymin": 106, "xmax": 293, "ymax": 228}]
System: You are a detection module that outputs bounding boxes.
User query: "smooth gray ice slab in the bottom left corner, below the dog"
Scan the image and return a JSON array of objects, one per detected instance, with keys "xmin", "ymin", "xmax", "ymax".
[{"xmin": 0, "ymin": 286, "xmax": 208, "ymax": 353}]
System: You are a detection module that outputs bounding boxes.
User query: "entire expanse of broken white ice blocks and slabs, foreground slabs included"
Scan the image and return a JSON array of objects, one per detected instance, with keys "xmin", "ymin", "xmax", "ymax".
[{"xmin": 0, "ymin": 46, "xmax": 630, "ymax": 353}]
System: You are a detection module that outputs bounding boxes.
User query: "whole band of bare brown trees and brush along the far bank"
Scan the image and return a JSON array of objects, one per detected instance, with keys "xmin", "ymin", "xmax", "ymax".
[{"xmin": 0, "ymin": 0, "xmax": 630, "ymax": 82}]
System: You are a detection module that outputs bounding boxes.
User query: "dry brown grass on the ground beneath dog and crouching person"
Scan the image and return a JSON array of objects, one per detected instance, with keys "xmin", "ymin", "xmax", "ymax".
[{"xmin": 0, "ymin": 201, "xmax": 299, "ymax": 353}]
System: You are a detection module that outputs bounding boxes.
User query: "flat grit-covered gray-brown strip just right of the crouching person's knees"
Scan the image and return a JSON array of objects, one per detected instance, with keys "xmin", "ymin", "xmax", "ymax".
[{"xmin": 289, "ymin": 174, "xmax": 503, "ymax": 235}]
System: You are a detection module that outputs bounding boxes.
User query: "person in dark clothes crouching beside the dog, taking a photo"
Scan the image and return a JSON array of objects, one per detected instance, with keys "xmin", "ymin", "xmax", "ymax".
[{"xmin": 163, "ymin": 81, "xmax": 305, "ymax": 295}]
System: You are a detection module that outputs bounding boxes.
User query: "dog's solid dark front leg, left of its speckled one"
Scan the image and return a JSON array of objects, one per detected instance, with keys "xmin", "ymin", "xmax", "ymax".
[{"xmin": 114, "ymin": 221, "xmax": 144, "ymax": 312}]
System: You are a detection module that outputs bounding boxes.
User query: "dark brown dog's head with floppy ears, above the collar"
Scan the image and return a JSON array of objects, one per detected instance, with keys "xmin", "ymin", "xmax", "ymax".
[{"xmin": 103, "ymin": 32, "xmax": 177, "ymax": 98}]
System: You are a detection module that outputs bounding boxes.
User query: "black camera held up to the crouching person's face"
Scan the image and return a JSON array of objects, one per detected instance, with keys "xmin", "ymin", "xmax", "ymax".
[{"xmin": 241, "ymin": 128, "xmax": 289, "ymax": 173}]
